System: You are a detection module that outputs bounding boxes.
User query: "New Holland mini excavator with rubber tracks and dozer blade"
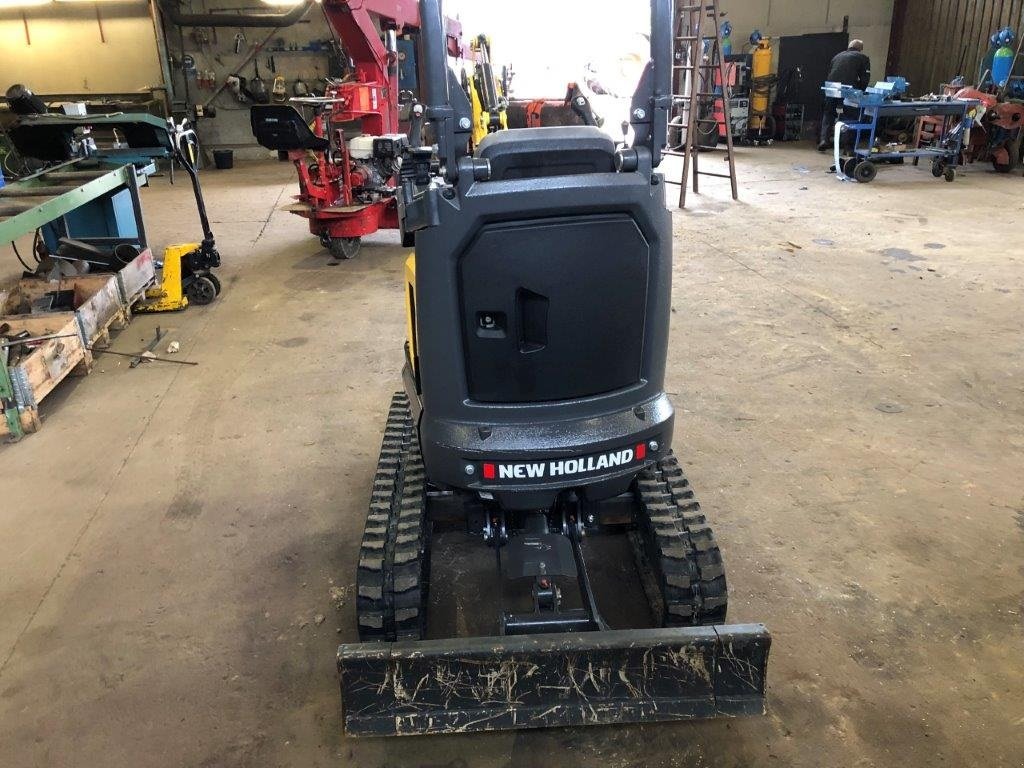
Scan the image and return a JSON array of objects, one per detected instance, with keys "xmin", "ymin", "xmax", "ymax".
[{"xmin": 337, "ymin": 0, "xmax": 770, "ymax": 735}]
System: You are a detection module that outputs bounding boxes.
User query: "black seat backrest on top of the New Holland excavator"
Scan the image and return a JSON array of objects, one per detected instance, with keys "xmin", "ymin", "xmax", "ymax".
[{"xmin": 476, "ymin": 125, "xmax": 615, "ymax": 181}]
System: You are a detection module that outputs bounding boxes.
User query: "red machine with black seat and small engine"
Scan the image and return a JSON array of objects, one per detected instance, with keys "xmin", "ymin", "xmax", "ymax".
[{"xmin": 251, "ymin": 0, "xmax": 464, "ymax": 259}]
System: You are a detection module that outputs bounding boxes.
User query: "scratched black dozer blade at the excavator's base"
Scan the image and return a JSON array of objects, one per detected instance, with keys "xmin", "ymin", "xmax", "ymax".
[{"xmin": 338, "ymin": 625, "xmax": 771, "ymax": 736}]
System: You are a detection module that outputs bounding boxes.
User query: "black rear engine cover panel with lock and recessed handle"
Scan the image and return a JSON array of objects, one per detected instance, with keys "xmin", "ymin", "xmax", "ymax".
[{"xmin": 460, "ymin": 214, "xmax": 649, "ymax": 402}]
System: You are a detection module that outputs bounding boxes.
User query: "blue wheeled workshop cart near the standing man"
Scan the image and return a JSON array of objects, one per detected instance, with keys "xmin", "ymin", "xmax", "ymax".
[{"xmin": 821, "ymin": 78, "xmax": 978, "ymax": 184}]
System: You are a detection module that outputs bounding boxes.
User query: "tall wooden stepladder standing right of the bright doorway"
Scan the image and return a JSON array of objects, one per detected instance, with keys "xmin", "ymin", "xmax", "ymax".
[{"xmin": 665, "ymin": 0, "xmax": 739, "ymax": 208}]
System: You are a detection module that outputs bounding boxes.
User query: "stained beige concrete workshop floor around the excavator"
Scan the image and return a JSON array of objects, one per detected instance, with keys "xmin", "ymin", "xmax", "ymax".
[{"xmin": 0, "ymin": 146, "xmax": 1024, "ymax": 768}]
